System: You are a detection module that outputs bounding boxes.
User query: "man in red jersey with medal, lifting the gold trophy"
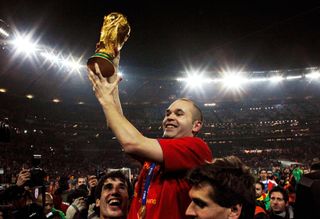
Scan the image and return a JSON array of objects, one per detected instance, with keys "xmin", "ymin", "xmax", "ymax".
[{"xmin": 88, "ymin": 54, "xmax": 212, "ymax": 219}]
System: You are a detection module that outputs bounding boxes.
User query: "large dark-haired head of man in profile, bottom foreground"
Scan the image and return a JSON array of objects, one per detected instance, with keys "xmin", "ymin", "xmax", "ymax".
[{"xmin": 186, "ymin": 156, "xmax": 255, "ymax": 219}]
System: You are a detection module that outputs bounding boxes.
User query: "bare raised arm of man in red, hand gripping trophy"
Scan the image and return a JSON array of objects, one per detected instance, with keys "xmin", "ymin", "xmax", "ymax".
[{"xmin": 88, "ymin": 64, "xmax": 163, "ymax": 162}]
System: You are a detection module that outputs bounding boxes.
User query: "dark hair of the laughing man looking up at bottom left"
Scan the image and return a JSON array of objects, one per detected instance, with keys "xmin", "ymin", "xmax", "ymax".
[{"xmin": 94, "ymin": 170, "xmax": 133, "ymax": 199}]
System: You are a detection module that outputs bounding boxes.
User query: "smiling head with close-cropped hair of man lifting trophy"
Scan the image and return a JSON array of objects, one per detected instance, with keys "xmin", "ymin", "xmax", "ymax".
[{"xmin": 162, "ymin": 98, "xmax": 203, "ymax": 138}]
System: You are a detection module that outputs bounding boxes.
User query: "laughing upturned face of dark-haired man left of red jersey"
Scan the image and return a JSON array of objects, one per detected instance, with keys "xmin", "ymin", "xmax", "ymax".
[{"xmin": 96, "ymin": 178, "xmax": 129, "ymax": 218}]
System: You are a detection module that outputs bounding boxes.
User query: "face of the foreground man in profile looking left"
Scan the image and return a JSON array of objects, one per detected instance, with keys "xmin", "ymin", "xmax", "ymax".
[{"xmin": 186, "ymin": 184, "xmax": 230, "ymax": 219}]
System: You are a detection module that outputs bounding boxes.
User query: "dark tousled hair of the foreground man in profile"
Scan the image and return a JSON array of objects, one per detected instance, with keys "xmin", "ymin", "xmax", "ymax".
[{"xmin": 187, "ymin": 156, "xmax": 255, "ymax": 219}]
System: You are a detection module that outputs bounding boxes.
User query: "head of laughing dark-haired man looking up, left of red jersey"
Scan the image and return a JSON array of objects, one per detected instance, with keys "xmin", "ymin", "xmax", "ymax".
[{"xmin": 95, "ymin": 171, "xmax": 132, "ymax": 218}]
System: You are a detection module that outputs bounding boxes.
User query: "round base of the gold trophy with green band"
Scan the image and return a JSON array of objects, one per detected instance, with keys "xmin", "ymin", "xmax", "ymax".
[{"xmin": 87, "ymin": 53, "xmax": 115, "ymax": 78}]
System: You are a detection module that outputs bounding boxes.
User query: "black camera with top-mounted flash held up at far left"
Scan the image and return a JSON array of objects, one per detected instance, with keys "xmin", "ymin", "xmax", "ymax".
[{"xmin": 27, "ymin": 154, "xmax": 46, "ymax": 187}]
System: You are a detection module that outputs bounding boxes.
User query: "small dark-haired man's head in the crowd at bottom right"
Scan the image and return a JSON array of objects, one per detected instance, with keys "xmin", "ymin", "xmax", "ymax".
[{"xmin": 269, "ymin": 186, "xmax": 289, "ymax": 213}]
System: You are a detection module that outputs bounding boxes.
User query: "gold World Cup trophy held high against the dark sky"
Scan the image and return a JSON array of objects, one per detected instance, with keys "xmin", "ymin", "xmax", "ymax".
[{"xmin": 87, "ymin": 12, "xmax": 131, "ymax": 78}]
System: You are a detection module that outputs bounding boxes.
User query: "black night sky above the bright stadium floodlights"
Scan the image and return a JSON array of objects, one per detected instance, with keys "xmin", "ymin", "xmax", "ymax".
[{"xmin": 0, "ymin": 0, "xmax": 320, "ymax": 78}]
